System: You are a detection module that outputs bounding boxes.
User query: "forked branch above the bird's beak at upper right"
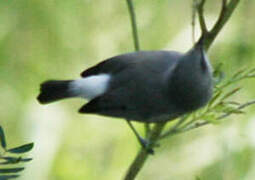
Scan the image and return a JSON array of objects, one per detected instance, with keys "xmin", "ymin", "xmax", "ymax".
[{"xmin": 198, "ymin": 0, "xmax": 240, "ymax": 51}]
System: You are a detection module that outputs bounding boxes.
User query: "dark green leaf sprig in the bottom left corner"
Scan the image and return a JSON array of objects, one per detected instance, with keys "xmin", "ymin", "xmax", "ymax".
[{"xmin": 0, "ymin": 126, "xmax": 34, "ymax": 180}]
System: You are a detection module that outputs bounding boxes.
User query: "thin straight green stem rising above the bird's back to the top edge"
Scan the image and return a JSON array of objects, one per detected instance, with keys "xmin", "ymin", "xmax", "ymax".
[{"xmin": 127, "ymin": 0, "xmax": 140, "ymax": 51}]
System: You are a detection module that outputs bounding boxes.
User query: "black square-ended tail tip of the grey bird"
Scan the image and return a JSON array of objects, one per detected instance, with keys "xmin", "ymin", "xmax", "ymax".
[{"xmin": 37, "ymin": 80, "xmax": 72, "ymax": 104}]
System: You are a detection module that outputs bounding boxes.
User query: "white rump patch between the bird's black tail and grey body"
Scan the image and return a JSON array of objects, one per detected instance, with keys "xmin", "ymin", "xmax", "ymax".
[{"xmin": 69, "ymin": 74, "xmax": 111, "ymax": 100}]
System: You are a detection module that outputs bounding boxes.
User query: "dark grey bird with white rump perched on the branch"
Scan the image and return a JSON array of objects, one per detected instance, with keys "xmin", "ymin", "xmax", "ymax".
[{"xmin": 38, "ymin": 40, "xmax": 213, "ymax": 153}]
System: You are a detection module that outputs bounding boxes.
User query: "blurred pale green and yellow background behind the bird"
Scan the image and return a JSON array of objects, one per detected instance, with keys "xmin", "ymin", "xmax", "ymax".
[{"xmin": 0, "ymin": 0, "xmax": 255, "ymax": 180}]
